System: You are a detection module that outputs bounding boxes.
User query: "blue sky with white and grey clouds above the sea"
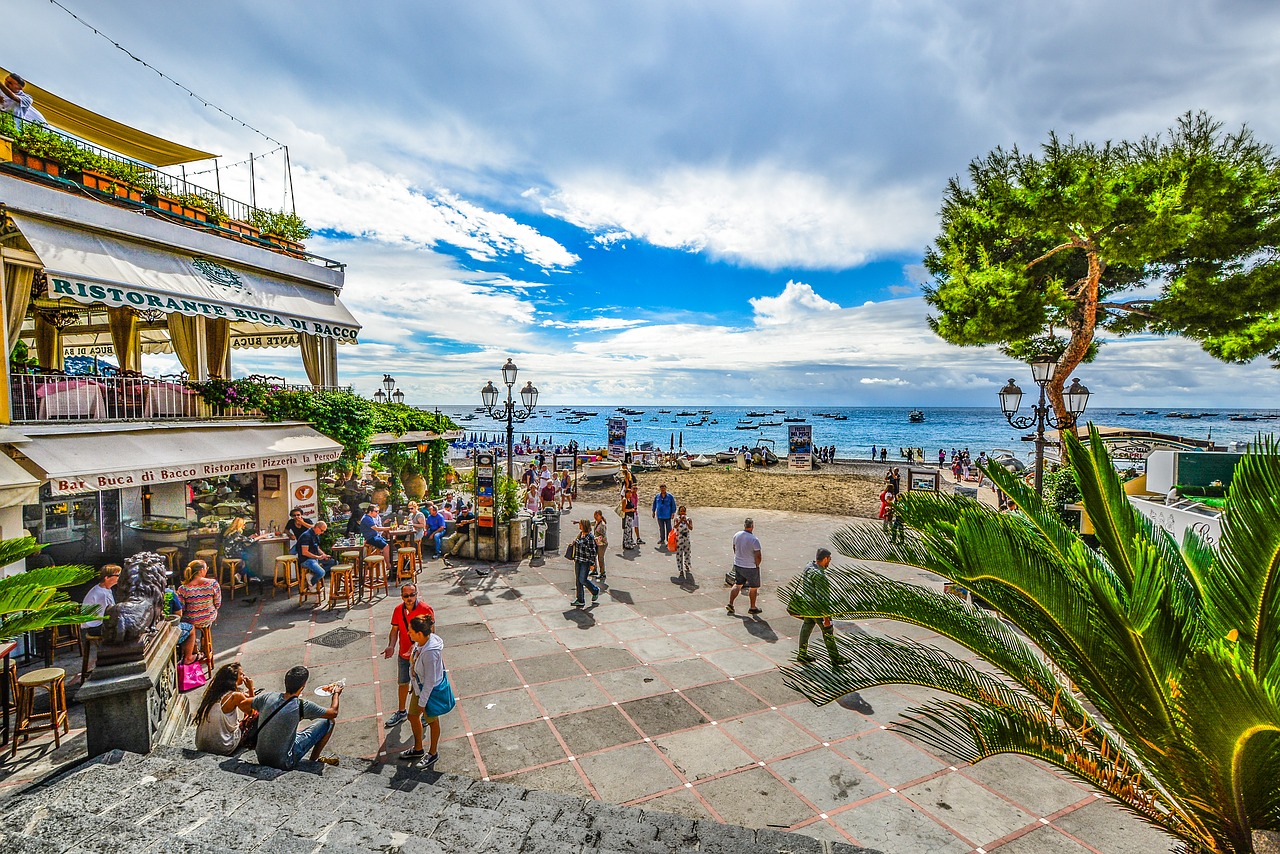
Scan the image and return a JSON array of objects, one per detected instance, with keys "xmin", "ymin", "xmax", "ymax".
[{"xmin": 10, "ymin": 0, "xmax": 1280, "ymax": 407}]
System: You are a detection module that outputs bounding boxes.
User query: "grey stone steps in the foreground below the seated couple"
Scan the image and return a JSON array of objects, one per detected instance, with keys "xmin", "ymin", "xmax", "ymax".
[{"xmin": 0, "ymin": 746, "xmax": 874, "ymax": 854}]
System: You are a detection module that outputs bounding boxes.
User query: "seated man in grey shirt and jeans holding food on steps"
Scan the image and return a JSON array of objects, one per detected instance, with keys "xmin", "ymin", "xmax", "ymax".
[{"xmin": 253, "ymin": 665, "xmax": 342, "ymax": 771}]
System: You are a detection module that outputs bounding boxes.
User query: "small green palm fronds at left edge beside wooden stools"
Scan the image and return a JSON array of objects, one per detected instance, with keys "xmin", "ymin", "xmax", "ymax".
[{"xmin": 0, "ymin": 536, "xmax": 97, "ymax": 640}]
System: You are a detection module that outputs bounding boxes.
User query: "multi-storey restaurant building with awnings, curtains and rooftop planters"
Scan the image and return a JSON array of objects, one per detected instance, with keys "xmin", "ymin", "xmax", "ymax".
[{"xmin": 0, "ymin": 72, "xmax": 360, "ymax": 571}]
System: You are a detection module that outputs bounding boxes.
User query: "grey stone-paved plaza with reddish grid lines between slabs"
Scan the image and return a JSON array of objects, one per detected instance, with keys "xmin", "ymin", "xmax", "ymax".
[{"xmin": 2, "ymin": 504, "xmax": 1169, "ymax": 854}]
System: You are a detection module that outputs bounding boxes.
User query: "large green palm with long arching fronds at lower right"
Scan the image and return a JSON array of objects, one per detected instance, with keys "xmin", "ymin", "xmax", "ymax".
[{"xmin": 781, "ymin": 431, "xmax": 1280, "ymax": 854}]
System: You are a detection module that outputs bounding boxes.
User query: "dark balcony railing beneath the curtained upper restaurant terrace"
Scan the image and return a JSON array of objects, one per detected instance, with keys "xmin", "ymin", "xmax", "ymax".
[{"xmin": 9, "ymin": 374, "xmax": 349, "ymax": 424}]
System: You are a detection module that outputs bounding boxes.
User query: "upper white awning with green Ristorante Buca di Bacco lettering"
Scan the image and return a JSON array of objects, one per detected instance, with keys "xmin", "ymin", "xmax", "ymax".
[{"xmin": 10, "ymin": 214, "xmax": 360, "ymax": 342}]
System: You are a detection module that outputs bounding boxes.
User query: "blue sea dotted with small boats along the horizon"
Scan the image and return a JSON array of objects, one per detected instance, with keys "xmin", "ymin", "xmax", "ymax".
[{"xmin": 440, "ymin": 405, "xmax": 1280, "ymax": 458}]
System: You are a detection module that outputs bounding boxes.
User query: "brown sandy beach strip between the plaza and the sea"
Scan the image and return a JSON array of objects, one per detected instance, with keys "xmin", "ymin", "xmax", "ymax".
[{"xmin": 579, "ymin": 461, "xmax": 886, "ymax": 519}]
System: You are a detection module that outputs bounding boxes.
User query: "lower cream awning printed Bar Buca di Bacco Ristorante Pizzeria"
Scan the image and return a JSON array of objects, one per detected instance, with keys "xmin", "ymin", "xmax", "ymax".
[{"xmin": 17, "ymin": 423, "xmax": 342, "ymax": 495}]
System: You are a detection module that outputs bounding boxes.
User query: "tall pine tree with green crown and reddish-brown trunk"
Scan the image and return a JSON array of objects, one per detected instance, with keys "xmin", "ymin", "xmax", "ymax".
[{"xmin": 924, "ymin": 113, "xmax": 1280, "ymax": 415}]
